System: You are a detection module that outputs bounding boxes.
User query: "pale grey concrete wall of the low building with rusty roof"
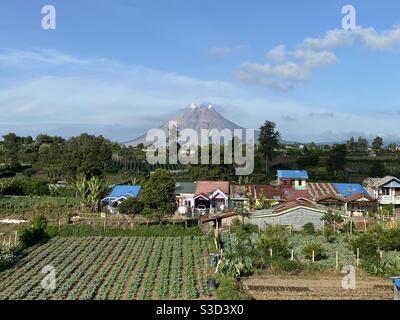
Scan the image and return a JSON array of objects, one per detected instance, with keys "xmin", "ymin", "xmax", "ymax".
[{"xmin": 250, "ymin": 208, "xmax": 324, "ymax": 229}]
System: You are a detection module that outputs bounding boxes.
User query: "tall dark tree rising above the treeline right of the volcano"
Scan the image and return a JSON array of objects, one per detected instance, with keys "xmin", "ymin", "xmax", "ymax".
[{"xmin": 258, "ymin": 121, "xmax": 281, "ymax": 181}]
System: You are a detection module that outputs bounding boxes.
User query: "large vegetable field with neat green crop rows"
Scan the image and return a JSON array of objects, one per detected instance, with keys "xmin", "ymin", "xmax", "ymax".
[{"xmin": 0, "ymin": 237, "xmax": 209, "ymax": 300}]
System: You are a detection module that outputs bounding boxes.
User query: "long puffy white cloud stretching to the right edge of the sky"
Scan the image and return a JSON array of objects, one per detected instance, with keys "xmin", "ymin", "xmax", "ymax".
[{"xmin": 235, "ymin": 27, "xmax": 400, "ymax": 90}]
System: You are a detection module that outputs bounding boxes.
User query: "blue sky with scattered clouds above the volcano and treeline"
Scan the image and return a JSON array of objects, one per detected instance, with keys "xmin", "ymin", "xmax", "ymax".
[{"xmin": 0, "ymin": 0, "xmax": 400, "ymax": 142}]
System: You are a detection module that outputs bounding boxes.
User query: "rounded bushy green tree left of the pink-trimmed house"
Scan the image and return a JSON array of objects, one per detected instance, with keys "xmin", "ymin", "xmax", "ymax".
[{"xmin": 141, "ymin": 169, "xmax": 176, "ymax": 220}]
